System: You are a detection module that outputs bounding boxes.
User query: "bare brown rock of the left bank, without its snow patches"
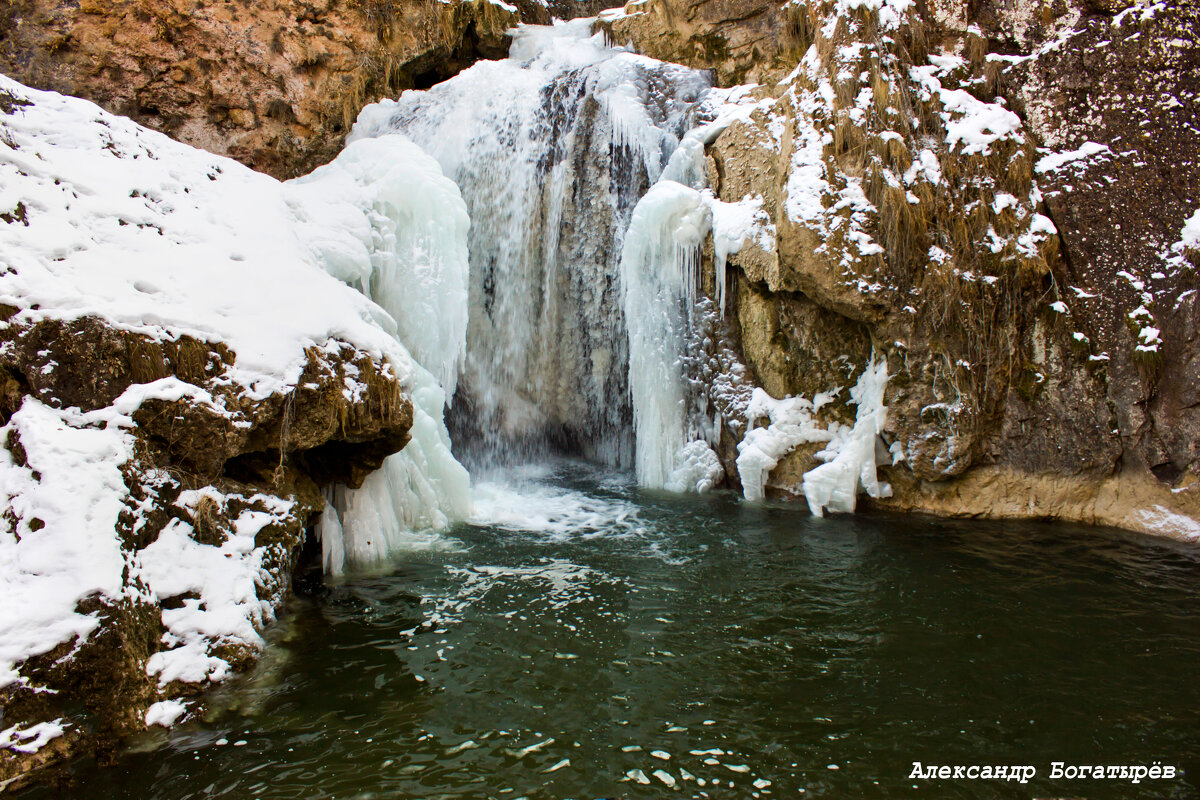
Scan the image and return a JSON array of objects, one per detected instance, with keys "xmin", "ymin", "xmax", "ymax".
[{"xmin": 0, "ymin": 318, "xmax": 413, "ymax": 786}]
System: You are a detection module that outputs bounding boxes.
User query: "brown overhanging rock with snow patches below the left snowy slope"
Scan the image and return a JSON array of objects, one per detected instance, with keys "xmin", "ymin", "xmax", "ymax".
[{"xmin": 0, "ymin": 318, "xmax": 413, "ymax": 783}]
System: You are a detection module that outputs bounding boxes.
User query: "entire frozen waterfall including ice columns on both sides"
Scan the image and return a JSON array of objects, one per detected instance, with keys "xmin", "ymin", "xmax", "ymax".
[{"xmin": 304, "ymin": 19, "xmax": 892, "ymax": 573}]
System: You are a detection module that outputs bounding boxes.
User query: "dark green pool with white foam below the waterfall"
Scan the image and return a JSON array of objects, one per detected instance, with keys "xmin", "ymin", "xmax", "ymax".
[{"xmin": 17, "ymin": 464, "xmax": 1200, "ymax": 800}]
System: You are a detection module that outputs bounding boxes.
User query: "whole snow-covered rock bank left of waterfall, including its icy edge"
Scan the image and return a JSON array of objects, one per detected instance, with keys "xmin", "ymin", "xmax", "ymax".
[{"xmin": 0, "ymin": 77, "xmax": 467, "ymax": 783}]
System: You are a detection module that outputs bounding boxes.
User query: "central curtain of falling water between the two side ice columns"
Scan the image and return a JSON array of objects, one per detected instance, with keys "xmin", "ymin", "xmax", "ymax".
[{"xmin": 350, "ymin": 20, "xmax": 709, "ymax": 467}]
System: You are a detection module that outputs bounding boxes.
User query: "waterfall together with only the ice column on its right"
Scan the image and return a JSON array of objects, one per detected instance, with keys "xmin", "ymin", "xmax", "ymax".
[{"xmin": 348, "ymin": 20, "xmax": 774, "ymax": 494}]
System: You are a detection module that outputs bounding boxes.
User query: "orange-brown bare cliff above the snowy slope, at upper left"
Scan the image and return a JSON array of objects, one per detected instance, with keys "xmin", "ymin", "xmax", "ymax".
[{"xmin": 0, "ymin": 0, "xmax": 608, "ymax": 178}]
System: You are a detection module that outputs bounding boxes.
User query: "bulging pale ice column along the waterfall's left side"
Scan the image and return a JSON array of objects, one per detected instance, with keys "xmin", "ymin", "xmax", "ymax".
[{"xmin": 287, "ymin": 136, "xmax": 470, "ymax": 576}]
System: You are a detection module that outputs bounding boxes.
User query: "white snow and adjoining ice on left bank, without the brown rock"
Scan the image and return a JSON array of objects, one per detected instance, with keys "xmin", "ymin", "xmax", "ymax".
[{"xmin": 0, "ymin": 71, "xmax": 469, "ymax": 734}]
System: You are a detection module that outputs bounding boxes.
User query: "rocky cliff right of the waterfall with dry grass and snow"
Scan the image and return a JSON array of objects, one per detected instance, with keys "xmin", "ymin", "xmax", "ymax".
[{"xmin": 601, "ymin": 0, "xmax": 1200, "ymax": 539}]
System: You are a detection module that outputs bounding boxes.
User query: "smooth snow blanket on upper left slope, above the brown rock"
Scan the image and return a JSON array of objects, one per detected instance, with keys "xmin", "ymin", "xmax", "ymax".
[{"xmin": 0, "ymin": 77, "xmax": 408, "ymax": 397}]
